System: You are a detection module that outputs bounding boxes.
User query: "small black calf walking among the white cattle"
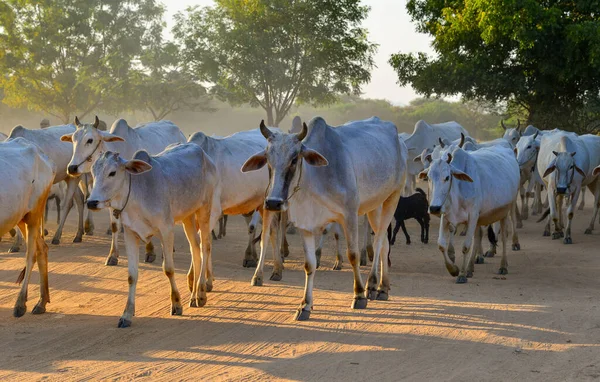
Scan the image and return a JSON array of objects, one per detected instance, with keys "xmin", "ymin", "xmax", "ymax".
[{"xmin": 390, "ymin": 188, "xmax": 429, "ymax": 245}]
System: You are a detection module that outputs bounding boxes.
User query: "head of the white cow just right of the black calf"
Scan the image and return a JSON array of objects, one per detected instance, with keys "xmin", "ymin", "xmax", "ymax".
[{"xmin": 419, "ymin": 153, "xmax": 473, "ymax": 215}]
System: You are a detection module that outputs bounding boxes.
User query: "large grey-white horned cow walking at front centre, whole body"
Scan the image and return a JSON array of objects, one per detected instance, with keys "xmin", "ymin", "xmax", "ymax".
[{"xmin": 242, "ymin": 117, "xmax": 406, "ymax": 320}]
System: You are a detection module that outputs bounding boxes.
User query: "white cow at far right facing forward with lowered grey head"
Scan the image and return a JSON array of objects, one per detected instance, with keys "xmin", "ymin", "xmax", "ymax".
[{"xmin": 537, "ymin": 131, "xmax": 593, "ymax": 244}]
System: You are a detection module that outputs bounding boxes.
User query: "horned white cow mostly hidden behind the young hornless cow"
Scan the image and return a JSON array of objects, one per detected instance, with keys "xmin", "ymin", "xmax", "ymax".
[{"xmin": 61, "ymin": 117, "xmax": 185, "ymax": 265}]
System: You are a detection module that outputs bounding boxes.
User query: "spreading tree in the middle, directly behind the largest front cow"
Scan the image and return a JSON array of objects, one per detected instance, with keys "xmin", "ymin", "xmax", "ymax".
[{"xmin": 174, "ymin": 0, "xmax": 375, "ymax": 126}]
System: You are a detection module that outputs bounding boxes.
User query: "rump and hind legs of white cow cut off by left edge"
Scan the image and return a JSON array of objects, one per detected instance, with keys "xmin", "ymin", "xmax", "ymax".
[{"xmin": 0, "ymin": 138, "xmax": 56, "ymax": 317}]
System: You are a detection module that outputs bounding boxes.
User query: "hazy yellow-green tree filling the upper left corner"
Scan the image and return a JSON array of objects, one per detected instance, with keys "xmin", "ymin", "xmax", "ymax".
[{"xmin": 0, "ymin": 0, "xmax": 163, "ymax": 123}]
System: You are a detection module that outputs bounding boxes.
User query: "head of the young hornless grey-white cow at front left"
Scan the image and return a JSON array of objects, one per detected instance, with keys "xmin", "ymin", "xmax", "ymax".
[{"xmin": 87, "ymin": 151, "xmax": 152, "ymax": 210}]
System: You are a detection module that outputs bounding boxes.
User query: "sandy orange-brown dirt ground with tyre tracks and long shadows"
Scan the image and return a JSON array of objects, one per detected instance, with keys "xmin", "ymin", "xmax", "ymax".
[{"xmin": 0, "ymin": 192, "xmax": 600, "ymax": 381}]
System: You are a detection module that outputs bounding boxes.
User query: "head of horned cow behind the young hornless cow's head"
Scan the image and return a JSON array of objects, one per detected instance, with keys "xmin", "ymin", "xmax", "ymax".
[{"xmin": 60, "ymin": 116, "xmax": 124, "ymax": 176}]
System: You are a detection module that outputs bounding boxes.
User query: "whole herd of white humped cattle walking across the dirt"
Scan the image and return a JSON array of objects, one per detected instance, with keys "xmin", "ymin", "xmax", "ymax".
[{"xmin": 0, "ymin": 117, "xmax": 600, "ymax": 327}]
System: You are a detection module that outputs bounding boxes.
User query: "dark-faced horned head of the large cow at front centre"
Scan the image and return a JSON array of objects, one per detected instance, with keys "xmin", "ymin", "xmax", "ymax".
[{"xmin": 242, "ymin": 121, "xmax": 329, "ymax": 211}]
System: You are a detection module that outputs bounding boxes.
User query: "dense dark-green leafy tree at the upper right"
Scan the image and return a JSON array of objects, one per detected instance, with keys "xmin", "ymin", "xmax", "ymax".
[{"xmin": 390, "ymin": 0, "xmax": 600, "ymax": 130}]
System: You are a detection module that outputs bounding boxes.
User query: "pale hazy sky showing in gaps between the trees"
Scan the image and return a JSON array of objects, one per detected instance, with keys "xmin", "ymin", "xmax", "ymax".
[{"xmin": 163, "ymin": 0, "xmax": 431, "ymax": 104}]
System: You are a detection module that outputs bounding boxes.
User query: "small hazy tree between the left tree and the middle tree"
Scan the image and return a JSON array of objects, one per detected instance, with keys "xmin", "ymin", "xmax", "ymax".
[{"xmin": 129, "ymin": 42, "xmax": 210, "ymax": 121}]
